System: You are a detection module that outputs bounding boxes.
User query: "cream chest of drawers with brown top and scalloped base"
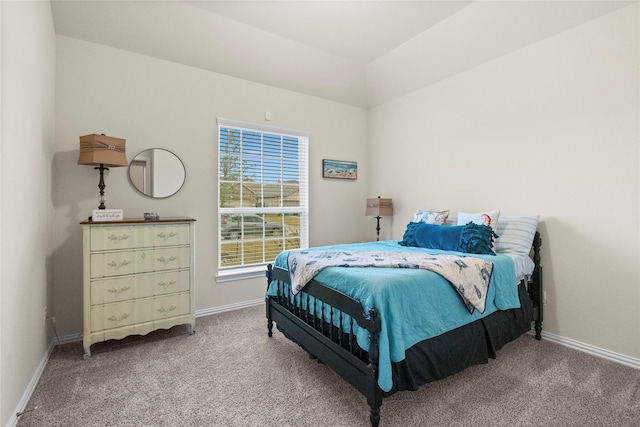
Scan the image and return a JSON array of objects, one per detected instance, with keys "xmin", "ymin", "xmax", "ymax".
[{"xmin": 81, "ymin": 218, "xmax": 195, "ymax": 358}]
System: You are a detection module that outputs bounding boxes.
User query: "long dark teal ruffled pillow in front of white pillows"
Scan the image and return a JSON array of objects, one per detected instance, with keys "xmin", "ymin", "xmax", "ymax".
[{"xmin": 400, "ymin": 222, "xmax": 498, "ymax": 255}]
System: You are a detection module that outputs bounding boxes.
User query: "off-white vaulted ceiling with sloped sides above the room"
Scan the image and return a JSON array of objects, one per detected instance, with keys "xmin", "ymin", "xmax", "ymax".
[{"xmin": 51, "ymin": 0, "xmax": 633, "ymax": 108}]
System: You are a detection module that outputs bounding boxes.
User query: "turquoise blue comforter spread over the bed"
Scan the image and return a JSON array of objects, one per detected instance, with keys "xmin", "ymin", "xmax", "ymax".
[{"xmin": 267, "ymin": 240, "xmax": 520, "ymax": 391}]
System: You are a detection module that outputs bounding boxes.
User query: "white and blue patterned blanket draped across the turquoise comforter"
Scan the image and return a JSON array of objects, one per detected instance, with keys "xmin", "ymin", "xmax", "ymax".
[{"xmin": 289, "ymin": 250, "xmax": 493, "ymax": 313}]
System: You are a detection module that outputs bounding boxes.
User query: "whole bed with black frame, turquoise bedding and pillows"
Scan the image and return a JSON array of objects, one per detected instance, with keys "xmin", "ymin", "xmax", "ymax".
[{"xmin": 266, "ymin": 213, "xmax": 543, "ymax": 427}]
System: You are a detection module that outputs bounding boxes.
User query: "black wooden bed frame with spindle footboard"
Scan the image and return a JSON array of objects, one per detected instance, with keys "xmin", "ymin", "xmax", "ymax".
[{"xmin": 266, "ymin": 232, "xmax": 543, "ymax": 427}]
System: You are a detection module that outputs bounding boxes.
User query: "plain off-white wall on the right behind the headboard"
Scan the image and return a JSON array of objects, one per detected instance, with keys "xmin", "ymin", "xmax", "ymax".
[{"xmin": 368, "ymin": 3, "xmax": 640, "ymax": 358}]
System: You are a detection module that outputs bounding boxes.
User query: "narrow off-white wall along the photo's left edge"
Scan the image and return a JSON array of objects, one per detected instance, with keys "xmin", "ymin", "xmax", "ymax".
[{"xmin": 0, "ymin": 1, "xmax": 55, "ymax": 425}]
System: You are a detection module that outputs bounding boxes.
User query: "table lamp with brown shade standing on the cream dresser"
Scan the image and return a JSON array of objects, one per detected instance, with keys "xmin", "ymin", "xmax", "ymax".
[{"xmin": 78, "ymin": 133, "xmax": 129, "ymax": 209}]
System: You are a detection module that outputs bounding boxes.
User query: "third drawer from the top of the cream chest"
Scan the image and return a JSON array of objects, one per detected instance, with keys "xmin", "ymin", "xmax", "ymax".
[{"xmin": 91, "ymin": 270, "xmax": 190, "ymax": 305}]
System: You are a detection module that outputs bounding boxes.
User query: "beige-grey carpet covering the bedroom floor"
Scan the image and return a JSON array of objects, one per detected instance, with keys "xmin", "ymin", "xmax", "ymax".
[{"xmin": 18, "ymin": 306, "xmax": 640, "ymax": 427}]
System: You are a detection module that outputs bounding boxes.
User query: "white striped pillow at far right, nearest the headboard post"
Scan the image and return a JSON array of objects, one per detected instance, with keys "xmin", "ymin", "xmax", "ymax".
[{"xmin": 495, "ymin": 215, "xmax": 540, "ymax": 256}]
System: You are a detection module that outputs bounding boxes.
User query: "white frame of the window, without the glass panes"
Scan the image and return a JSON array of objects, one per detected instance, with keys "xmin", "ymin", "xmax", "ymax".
[{"xmin": 216, "ymin": 117, "xmax": 310, "ymax": 282}]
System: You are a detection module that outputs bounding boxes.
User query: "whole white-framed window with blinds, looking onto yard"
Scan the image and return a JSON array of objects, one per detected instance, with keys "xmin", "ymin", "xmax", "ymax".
[{"xmin": 218, "ymin": 118, "xmax": 309, "ymax": 281}]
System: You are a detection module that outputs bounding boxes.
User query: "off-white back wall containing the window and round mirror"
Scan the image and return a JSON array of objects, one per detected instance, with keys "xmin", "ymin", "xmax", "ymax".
[{"xmin": 53, "ymin": 36, "xmax": 368, "ymax": 335}]
